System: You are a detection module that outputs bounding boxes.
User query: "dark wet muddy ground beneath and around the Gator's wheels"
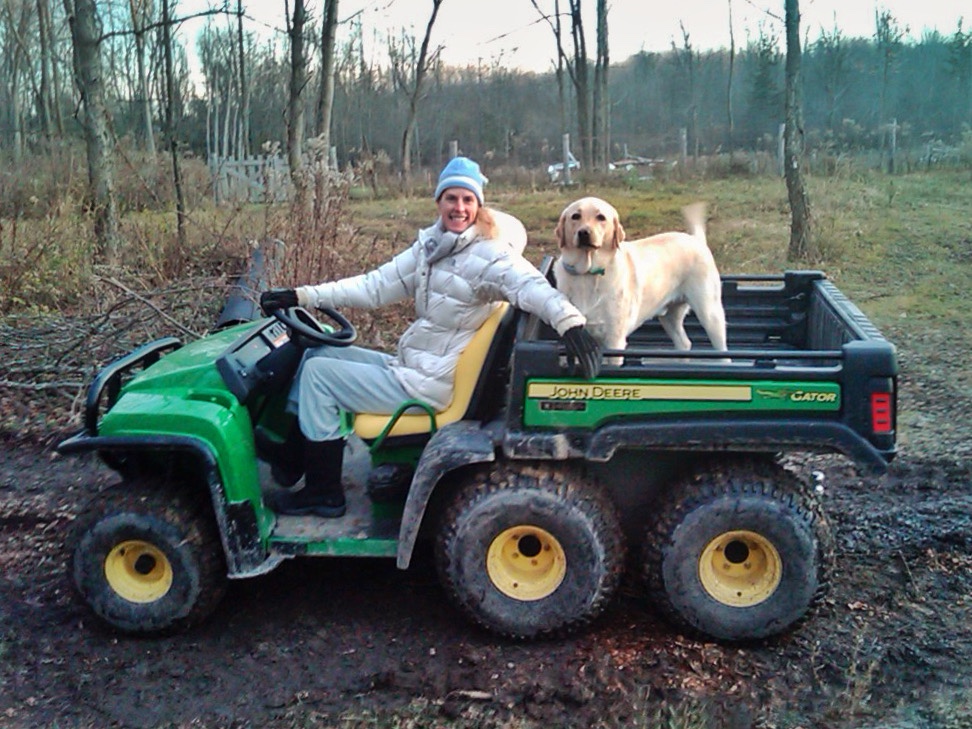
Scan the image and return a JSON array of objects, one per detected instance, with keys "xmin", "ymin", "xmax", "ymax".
[{"xmin": 0, "ymin": 332, "xmax": 972, "ymax": 729}]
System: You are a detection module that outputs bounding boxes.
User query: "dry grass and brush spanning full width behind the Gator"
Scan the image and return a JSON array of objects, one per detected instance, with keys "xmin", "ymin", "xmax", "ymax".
[{"xmin": 0, "ymin": 164, "xmax": 972, "ymax": 440}]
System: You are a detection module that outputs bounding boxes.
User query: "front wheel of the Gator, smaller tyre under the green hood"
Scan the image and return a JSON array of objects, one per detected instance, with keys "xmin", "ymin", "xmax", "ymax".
[{"xmin": 71, "ymin": 480, "xmax": 226, "ymax": 633}]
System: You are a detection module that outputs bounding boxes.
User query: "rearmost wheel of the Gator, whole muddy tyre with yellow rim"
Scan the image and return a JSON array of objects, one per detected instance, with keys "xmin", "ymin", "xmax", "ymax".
[{"xmin": 644, "ymin": 459, "xmax": 833, "ymax": 641}]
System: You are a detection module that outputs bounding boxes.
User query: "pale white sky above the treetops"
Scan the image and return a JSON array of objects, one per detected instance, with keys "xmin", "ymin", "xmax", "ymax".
[{"xmin": 188, "ymin": 0, "xmax": 972, "ymax": 72}]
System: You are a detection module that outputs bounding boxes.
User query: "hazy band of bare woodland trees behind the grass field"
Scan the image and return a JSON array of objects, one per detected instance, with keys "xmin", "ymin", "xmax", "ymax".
[{"xmin": 0, "ymin": 0, "xmax": 972, "ymax": 188}]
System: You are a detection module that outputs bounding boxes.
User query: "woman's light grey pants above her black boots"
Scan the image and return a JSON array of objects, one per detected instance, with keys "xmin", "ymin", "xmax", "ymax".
[{"xmin": 289, "ymin": 345, "xmax": 411, "ymax": 441}]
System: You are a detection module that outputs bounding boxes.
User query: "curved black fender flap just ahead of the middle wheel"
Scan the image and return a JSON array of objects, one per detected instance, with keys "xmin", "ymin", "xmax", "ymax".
[{"xmin": 397, "ymin": 420, "xmax": 497, "ymax": 570}]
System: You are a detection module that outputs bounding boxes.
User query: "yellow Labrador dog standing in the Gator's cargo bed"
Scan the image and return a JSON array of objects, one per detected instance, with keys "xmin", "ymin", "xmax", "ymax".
[{"xmin": 554, "ymin": 197, "xmax": 727, "ymax": 364}]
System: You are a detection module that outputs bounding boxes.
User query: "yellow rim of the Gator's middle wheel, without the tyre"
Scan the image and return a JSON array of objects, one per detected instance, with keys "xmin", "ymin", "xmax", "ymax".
[{"xmin": 486, "ymin": 525, "xmax": 567, "ymax": 601}]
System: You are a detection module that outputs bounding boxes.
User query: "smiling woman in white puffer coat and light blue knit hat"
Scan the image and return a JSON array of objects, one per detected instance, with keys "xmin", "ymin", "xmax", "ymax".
[{"xmin": 258, "ymin": 157, "xmax": 601, "ymax": 517}]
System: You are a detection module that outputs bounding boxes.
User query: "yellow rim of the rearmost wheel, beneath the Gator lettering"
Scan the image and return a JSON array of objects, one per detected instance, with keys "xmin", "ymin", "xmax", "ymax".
[{"xmin": 699, "ymin": 531, "xmax": 783, "ymax": 607}]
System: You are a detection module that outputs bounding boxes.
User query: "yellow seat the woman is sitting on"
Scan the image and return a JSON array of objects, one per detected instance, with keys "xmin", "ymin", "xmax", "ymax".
[{"xmin": 354, "ymin": 301, "xmax": 510, "ymax": 440}]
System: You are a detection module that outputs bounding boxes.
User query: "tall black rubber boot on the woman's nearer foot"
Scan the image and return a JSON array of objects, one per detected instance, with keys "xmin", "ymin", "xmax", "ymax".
[{"xmin": 267, "ymin": 438, "xmax": 347, "ymax": 519}]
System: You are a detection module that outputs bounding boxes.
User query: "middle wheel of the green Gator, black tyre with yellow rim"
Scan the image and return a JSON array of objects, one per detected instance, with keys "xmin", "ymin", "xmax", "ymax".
[{"xmin": 436, "ymin": 464, "xmax": 624, "ymax": 638}]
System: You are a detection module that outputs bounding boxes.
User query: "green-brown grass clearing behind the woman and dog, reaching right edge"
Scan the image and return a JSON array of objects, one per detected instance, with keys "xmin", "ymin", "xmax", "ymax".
[{"xmin": 352, "ymin": 172, "xmax": 972, "ymax": 338}]
